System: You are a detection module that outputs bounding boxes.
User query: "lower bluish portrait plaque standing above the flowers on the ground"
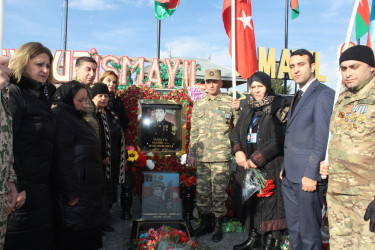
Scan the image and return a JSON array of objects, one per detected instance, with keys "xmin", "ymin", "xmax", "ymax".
[{"xmin": 142, "ymin": 172, "xmax": 182, "ymax": 220}]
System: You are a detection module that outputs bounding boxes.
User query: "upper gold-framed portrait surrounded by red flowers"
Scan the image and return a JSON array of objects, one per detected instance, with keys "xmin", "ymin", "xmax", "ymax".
[{"xmin": 138, "ymin": 99, "xmax": 186, "ymax": 154}]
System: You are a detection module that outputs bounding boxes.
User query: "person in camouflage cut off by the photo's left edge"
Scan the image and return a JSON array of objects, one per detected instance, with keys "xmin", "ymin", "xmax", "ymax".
[{"xmin": 0, "ymin": 56, "xmax": 17, "ymax": 249}]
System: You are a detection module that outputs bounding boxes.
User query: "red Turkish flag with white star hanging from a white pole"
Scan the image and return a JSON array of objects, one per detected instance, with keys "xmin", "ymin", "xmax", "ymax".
[{"xmin": 223, "ymin": 0, "xmax": 258, "ymax": 80}]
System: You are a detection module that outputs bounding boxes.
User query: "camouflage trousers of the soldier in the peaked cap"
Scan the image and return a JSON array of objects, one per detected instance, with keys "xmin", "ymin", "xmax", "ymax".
[{"xmin": 197, "ymin": 162, "xmax": 230, "ymax": 217}]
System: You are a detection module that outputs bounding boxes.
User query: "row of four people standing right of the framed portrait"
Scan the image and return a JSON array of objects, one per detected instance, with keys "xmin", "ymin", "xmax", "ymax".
[{"xmin": 190, "ymin": 45, "xmax": 375, "ymax": 250}]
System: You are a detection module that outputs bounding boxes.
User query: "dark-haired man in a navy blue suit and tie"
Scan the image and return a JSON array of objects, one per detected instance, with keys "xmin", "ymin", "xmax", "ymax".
[{"xmin": 280, "ymin": 49, "xmax": 335, "ymax": 250}]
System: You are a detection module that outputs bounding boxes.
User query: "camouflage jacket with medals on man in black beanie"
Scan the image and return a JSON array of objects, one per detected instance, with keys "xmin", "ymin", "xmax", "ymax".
[{"xmin": 328, "ymin": 78, "xmax": 375, "ymax": 195}]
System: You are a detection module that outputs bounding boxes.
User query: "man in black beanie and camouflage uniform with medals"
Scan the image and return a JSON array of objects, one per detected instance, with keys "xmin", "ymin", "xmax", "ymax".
[{"xmin": 320, "ymin": 45, "xmax": 375, "ymax": 249}]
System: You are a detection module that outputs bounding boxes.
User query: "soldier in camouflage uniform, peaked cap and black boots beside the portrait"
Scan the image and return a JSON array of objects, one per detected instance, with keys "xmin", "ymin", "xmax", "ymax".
[{"xmin": 190, "ymin": 70, "xmax": 240, "ymax": 241}]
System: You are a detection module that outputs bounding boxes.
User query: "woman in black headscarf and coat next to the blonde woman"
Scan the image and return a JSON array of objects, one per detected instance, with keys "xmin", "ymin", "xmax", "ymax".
[{"xmin": 53, "ymin": 81, "xmax": 105, "ymax": 249}]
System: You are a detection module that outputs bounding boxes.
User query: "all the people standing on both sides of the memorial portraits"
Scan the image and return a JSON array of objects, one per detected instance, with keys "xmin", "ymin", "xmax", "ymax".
[{"xmin": 0, "ymin": 42, "xmax": 375, "ymax": 250}]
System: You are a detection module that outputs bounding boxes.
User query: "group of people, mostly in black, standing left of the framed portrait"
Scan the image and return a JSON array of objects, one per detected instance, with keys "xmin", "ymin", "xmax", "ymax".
[{"xmin": 0, "ymin": 42, "xmax": 129, "ymax": 250}]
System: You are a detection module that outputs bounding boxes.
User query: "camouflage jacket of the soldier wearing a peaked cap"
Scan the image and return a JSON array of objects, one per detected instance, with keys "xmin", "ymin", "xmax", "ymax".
[{"xmin": 190, "ymin": 93, "xmax": 240, "ymax": 162}]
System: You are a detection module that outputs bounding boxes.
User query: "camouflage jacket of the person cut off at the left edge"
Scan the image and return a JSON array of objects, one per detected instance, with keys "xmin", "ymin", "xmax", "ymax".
[{"xmin": 0, "ymin": 89, "xmax": 16, "ymax": 194}]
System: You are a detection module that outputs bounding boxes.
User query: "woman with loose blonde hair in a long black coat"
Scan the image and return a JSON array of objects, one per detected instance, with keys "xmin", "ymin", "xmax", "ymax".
[{"xmin": 4, "ymin": 42, "xmax": 56, "ymax": 250}]
